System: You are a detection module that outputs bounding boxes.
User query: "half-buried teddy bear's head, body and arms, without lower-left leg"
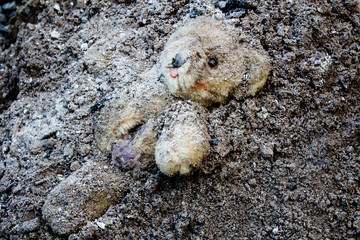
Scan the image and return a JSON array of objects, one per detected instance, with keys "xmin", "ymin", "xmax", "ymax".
[{"xmin": 96, "ymin": 17, "xmax": 270, "ymax": 176}]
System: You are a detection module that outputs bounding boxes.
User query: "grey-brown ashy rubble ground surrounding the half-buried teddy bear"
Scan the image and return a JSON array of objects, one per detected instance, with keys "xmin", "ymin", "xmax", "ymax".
[{"xmin": 0, "ymin": 0, "xmax": 360, "ymax": 239}]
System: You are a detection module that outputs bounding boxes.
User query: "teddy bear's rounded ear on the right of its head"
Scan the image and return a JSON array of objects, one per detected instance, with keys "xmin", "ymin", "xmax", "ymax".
[{"xmin": 244, "ymin": 50, "xmax": 271, "ymax": 96}]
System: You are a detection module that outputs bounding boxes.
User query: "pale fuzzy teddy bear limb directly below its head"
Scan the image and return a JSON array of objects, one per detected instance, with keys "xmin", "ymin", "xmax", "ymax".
[{"xmin": 155, "ymin": 101, "xmax": 210, "ymax": 176}]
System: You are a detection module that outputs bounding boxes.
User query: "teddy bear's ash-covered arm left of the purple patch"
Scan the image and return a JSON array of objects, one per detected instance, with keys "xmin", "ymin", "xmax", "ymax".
[{"xmin": 95, "ymin": 65, "xmax": 172, "ymax": 151}]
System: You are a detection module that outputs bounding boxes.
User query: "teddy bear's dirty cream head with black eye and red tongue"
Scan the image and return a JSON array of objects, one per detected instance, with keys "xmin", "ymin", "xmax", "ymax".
[{"xmin": 161, "ymin": 17, "xmax": 270, "ymax": 105}]
